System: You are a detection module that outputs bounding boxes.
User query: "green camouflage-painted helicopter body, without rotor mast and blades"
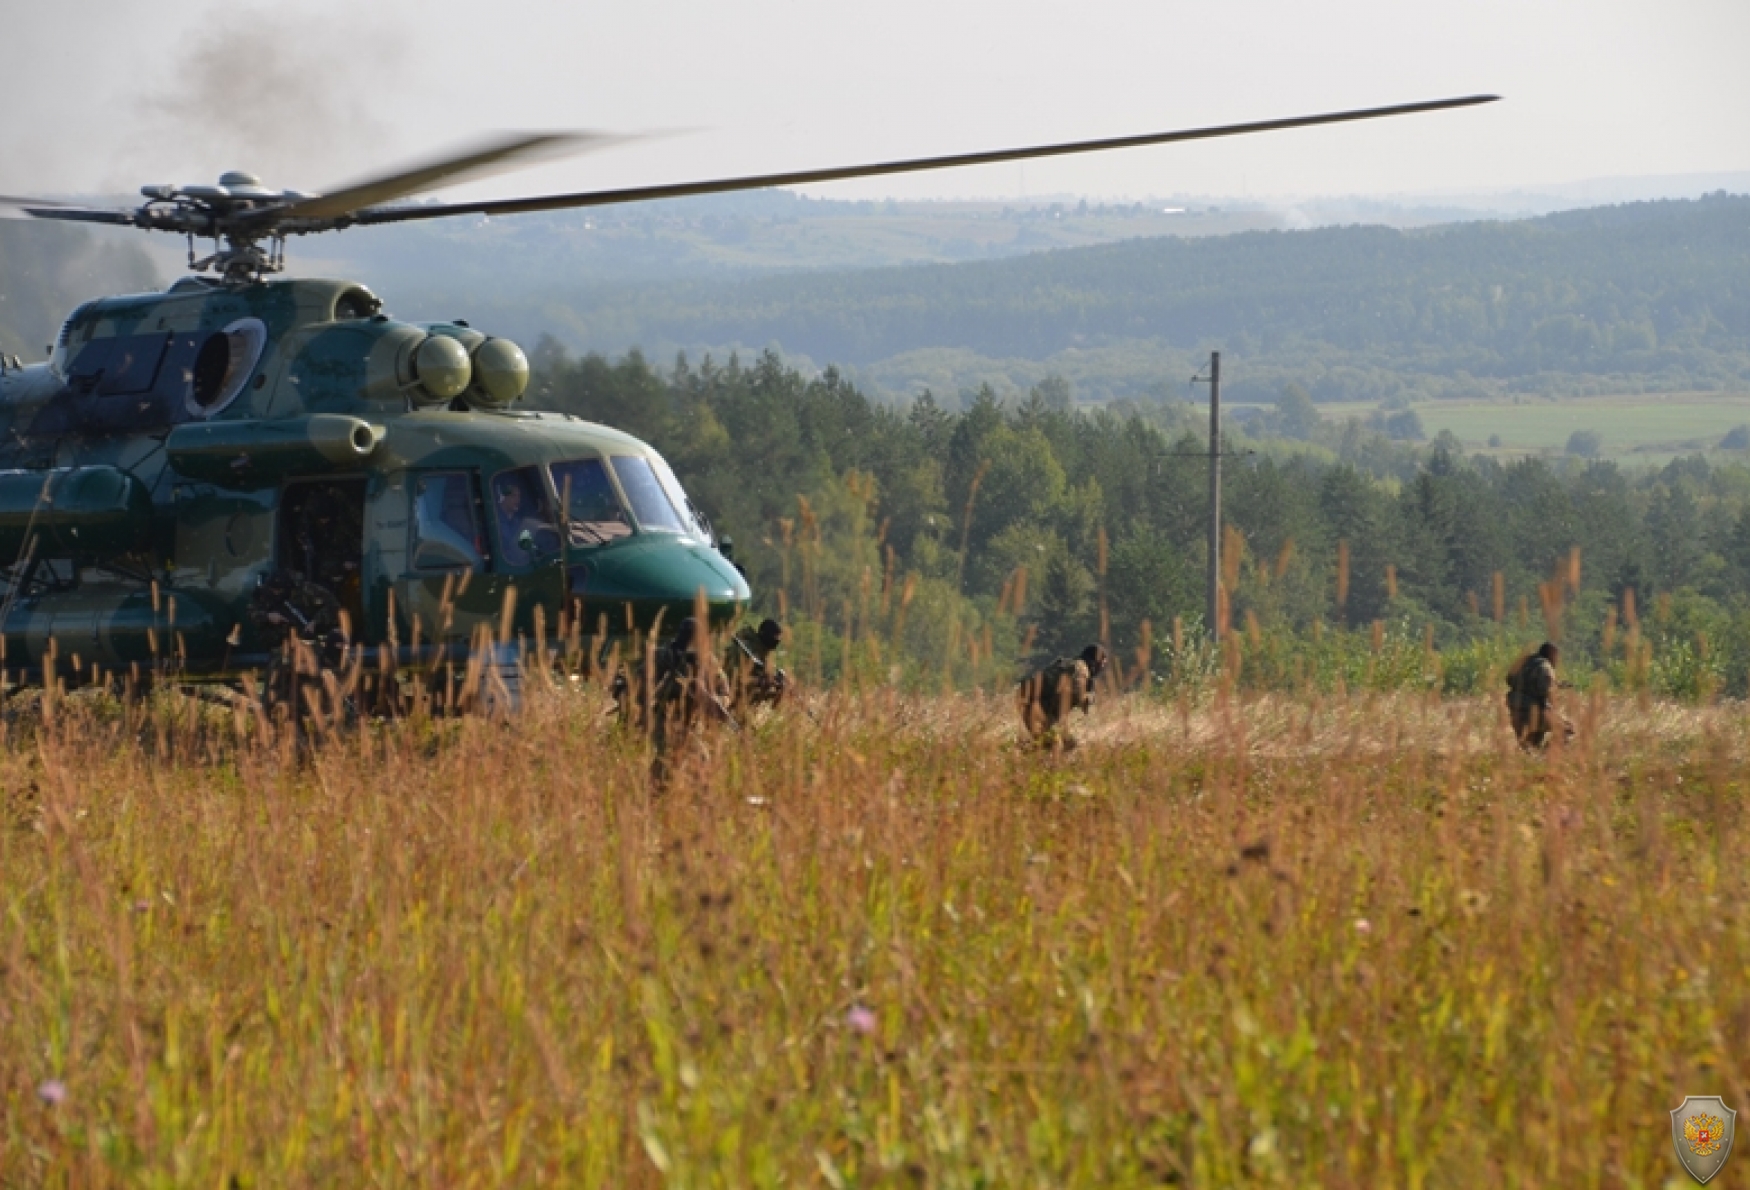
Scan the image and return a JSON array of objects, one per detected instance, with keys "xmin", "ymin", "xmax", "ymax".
[{"xmin": 0, "ymin": 278, "xmax": 749, "ymax": 677}]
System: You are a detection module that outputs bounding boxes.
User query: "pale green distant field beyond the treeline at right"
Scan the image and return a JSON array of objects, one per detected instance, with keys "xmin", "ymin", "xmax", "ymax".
[{"xmin": 1320, "ymin": 392, "xmax": 1750, "ymax": 464}]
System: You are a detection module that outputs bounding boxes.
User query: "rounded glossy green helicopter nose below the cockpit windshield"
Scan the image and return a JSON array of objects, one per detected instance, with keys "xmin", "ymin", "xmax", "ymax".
[{"xmin": 569, "ymin": 536, "xmax": 751, "ymax": 632}]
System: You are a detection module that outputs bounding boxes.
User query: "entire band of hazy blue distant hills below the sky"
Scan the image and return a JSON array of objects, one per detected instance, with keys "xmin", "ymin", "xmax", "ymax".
[{"xmin": 0, "ymin": 191, "xmax": 1750, "ymax": 403}]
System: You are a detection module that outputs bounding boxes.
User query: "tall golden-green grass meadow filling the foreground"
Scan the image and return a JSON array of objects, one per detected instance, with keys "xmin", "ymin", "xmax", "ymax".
[{"xmin": 0, "ymin": 691, "xmax": 1750, "ymax": 1187}]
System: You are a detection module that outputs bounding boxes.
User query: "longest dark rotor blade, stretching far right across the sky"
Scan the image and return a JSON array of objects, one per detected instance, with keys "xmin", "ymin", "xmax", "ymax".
[{"xmin": 351, "ymin": 95, "xmax": 1502, "ymax": 226}]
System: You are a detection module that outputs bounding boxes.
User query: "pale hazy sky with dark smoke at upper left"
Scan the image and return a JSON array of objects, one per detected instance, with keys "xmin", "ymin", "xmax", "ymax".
[{"xmin": 0, "ymin": 0, "xmax": 1750, "ymax": 198}]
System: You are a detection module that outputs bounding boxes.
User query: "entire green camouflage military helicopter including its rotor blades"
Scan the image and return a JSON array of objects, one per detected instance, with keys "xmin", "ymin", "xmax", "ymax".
[{"xmin": 0, "ymin": 95, "xmax": 1498, "ymax": 707}]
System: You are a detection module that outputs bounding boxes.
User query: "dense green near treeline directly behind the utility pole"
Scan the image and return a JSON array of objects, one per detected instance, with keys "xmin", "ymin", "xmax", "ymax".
[{"xmin": 534, "ymin": 347, "xmax": 1750, "ymax": 695}]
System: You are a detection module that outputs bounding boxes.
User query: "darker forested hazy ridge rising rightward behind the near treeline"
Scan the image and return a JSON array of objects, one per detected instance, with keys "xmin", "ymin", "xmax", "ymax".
[{"xmin": 535, "ymin": 194, "xmax": 1750, "ymax": 401}]
